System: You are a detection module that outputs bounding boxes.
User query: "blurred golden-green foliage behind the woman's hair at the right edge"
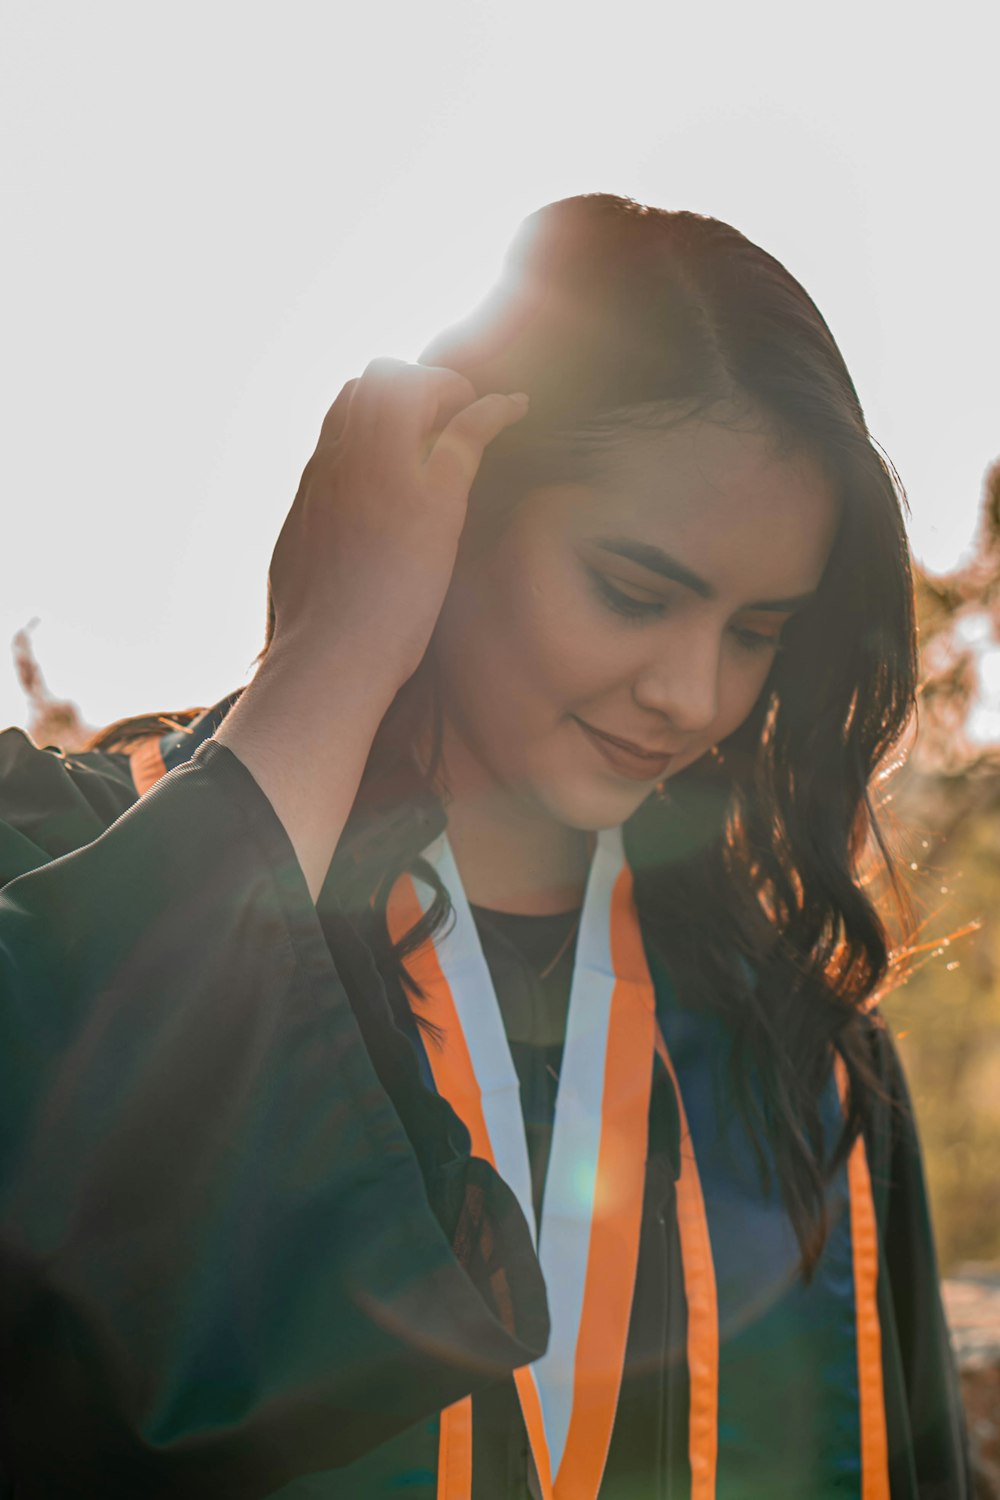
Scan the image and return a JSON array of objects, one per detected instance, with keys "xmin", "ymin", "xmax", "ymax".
[{"xmin": 883, "ymin": 464, "xmax": 1000, "ymax": 1271}]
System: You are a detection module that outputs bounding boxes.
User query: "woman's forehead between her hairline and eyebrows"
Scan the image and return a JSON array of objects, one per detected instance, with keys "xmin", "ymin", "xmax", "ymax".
[{"xmin": 559, "ymin": 420, "xmax": 838, "ymax": 600}]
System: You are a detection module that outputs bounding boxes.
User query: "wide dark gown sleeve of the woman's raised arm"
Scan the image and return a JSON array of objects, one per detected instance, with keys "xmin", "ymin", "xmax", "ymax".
[{"xmin": 0, "ymin": 731, "xmax": 547, "ymax": 1500}]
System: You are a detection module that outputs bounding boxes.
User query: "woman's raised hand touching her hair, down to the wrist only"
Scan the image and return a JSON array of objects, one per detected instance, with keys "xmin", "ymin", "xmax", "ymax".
[{"xmin": 270, "ymin": 359, "xmax": 528, "ymax": 687}]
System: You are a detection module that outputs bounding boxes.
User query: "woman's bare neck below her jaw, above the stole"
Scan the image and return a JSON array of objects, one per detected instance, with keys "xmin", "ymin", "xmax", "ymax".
[{"xmin": 431, "ymin": 723, "xmax": 594, "ymax": 915}]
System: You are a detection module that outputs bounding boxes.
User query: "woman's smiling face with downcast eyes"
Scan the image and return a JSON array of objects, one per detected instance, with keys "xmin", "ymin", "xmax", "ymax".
[{"xmin": 435, "ymin": 419, "xmax": 837, "ymax": 830}]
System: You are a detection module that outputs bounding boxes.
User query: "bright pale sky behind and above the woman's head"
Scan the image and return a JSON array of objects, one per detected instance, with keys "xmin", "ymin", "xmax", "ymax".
[{"xmin": 0, "ymin": 0, "xmax": 1000, "ymax": 738}]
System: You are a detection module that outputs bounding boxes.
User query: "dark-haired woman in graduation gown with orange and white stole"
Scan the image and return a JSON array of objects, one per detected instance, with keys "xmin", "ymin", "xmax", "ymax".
[{"xmin": 0, "ymin": 195, "xmax": 967, "ymax": 1500}]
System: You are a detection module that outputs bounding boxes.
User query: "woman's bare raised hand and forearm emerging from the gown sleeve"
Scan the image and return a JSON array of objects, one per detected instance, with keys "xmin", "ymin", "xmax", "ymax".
[{"xmin": 214, "ymin": 360, "xmax": 528, "ymax": 900}]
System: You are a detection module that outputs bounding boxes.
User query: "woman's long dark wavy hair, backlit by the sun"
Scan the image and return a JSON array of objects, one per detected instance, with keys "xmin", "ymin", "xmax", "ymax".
[{"xmin": 91, "ymin": 194, "xmax": 916, "ymax": 1275}]
